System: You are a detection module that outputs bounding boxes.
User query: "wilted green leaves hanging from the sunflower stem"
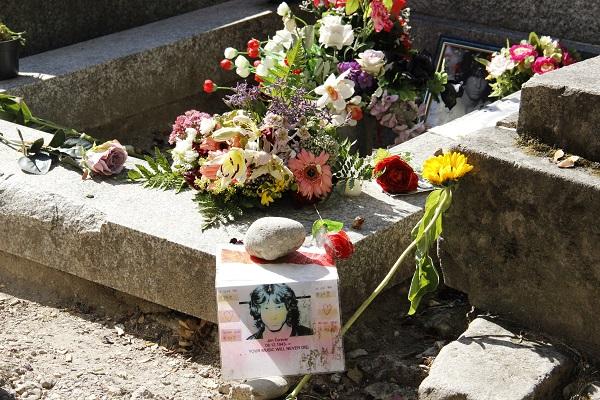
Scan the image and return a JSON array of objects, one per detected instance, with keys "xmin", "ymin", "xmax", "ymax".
[{"xmin": 408, "ymin": 187, "xmax": 452, "ymax": 315}]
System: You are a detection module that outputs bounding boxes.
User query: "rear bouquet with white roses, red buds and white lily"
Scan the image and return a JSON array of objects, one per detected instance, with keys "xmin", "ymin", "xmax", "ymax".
[{"xmin": 208, "ymin": 0, "xmax": 447, "ymax": 142}]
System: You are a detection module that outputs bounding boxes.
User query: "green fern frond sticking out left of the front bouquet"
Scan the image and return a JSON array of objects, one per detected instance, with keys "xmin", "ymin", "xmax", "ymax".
[{"xmin": 127, "ymin": 147, "xmax": 185, "ymax": 193}]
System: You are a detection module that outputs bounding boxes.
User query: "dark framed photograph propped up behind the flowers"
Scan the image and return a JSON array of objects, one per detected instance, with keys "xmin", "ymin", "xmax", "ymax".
[{"xmin": 425, "ymin": 36, "xmax": 500, "ymax": 127}]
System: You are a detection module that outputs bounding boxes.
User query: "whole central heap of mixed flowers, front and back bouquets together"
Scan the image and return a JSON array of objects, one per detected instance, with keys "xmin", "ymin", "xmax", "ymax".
[{"xmin": 129, "ymin": 0, "xmax": 446, "ymax": 228}]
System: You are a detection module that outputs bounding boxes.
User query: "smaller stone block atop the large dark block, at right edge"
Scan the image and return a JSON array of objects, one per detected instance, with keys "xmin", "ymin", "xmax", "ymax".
[{"xmin": 518, "ymin": 57, "xmax": 600, "ymax": 161}]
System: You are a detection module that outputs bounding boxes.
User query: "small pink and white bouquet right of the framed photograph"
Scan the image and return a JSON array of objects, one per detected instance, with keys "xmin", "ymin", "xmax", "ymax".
[{"xmin": 480, "ymin": 32, "xmax": 580, "ymax": 97}]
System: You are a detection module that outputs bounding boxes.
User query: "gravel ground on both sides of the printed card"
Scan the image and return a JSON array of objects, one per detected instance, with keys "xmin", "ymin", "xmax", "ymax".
[{"xmin": 0, "ymin": 280, "xmax": 468, "ymax": 400}]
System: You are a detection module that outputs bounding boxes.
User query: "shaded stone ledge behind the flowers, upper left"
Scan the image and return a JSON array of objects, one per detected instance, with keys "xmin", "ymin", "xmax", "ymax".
[{"xmin": 0, "ymin": 0, "xmax": 281, "ymax": 148}]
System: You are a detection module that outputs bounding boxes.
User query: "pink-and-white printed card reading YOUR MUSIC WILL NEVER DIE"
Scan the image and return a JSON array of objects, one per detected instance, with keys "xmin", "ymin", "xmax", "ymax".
[{"xmin": 215, "ymin": 246, "xmax": 344, "ymax": 379}]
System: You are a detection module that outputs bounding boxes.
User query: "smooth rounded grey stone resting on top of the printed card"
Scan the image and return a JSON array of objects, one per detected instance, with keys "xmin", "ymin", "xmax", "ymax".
[{"xmin": 244, "ymin": 217, "xmax": 306, "ymax": 261}]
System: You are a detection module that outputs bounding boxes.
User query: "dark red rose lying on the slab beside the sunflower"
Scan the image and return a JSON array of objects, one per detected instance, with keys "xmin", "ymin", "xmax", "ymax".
[{"xmin": 373, "ymin": 156, "xmax": 419, "ymax": 194}]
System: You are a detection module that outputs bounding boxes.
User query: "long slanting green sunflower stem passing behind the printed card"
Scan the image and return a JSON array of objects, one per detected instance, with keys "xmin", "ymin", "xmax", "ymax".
[{"xmin": 286, "ymin": 188, "xmax": 450, "ymax": 400}]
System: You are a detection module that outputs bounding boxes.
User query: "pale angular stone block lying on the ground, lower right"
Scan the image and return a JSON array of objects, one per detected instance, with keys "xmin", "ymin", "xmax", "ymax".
[{"xmin": 419, "ymin": 318, "xmax": 574, "ymax": 400}]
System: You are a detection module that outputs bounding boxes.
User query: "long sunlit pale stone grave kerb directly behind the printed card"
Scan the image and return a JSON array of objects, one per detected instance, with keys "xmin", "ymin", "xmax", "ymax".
[{"xmin": 0, "ymin": 121, "xmax": 441, "ymax": 321}]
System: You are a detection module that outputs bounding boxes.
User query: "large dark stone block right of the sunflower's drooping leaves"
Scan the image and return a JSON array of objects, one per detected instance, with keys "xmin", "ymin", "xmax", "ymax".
[{"xmin": 440, "ymin": 128, "xmax": 600, "ymax": 358}]
